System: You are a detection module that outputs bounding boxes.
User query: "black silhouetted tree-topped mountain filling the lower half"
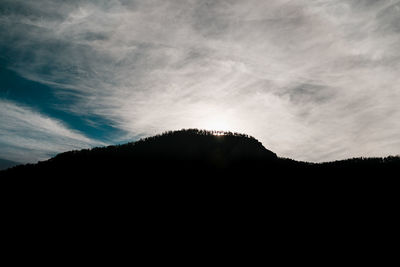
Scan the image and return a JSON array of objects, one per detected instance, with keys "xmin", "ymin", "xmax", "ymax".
[{"xmin": 0, "ymin": 130, "xmax": 400, "ymax": 264}]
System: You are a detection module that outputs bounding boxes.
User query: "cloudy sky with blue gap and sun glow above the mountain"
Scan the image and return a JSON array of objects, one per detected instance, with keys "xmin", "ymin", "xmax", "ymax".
[{"xmin": 0, "ymin": 0, "xmax": 400, "ymax": 163}]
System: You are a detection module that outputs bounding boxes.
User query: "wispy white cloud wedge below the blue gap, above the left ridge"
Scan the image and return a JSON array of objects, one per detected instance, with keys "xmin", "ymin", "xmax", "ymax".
[{"xmin": 0, "ymin": 99, "xmax": 105, "ymax": 162}]
